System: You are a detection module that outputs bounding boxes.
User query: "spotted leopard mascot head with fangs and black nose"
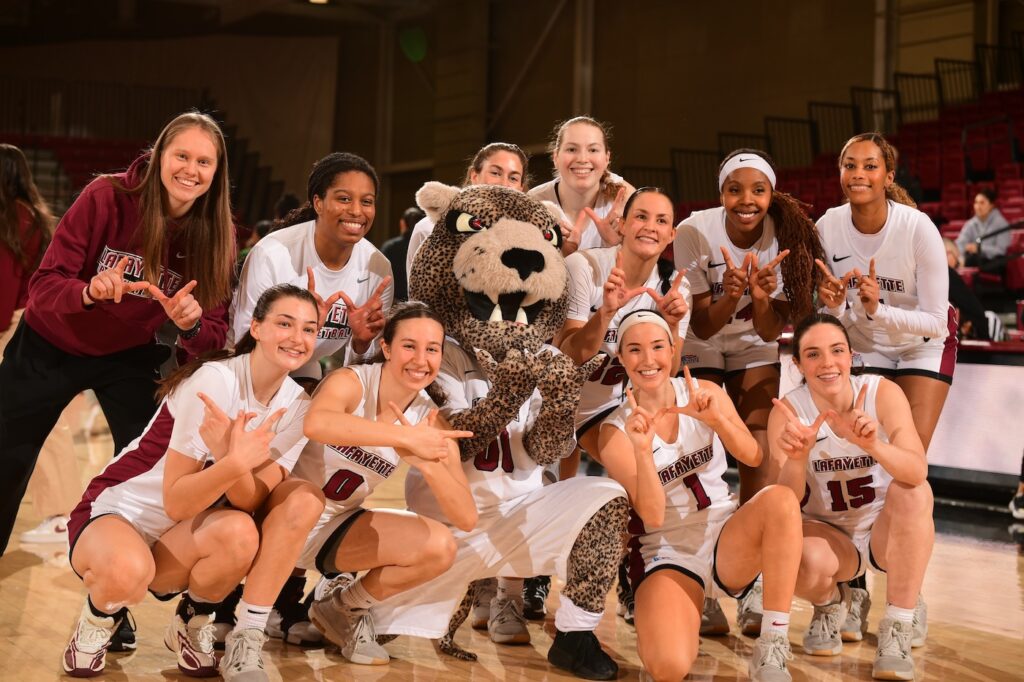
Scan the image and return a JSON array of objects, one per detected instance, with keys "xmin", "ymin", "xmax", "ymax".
[{"xmin": 409, "ymin": 182, "xmax": 568, "ymax": 360}]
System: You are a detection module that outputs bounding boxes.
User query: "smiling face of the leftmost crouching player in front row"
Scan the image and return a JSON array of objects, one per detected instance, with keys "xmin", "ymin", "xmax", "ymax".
[{"xmin": 249, "ymin": 296, "xmax": 317, "ymax": 373}]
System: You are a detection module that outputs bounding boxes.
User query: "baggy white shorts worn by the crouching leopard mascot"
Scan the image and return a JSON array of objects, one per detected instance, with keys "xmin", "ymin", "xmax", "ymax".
[{"xmin": 371, "ymin": 476, "xmax": 626, "ymax": 639}]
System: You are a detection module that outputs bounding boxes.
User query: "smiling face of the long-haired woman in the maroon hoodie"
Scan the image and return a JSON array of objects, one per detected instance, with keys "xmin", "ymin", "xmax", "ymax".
[{"xmin": 160, "ymin": 126, "xmax": 218, "ymax": 218}]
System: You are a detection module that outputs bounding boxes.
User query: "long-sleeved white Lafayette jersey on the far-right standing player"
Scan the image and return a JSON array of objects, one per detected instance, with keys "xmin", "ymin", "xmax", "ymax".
[{"xmin": 817, "ymin": 201, "xmax": 949, "ymax": 353}]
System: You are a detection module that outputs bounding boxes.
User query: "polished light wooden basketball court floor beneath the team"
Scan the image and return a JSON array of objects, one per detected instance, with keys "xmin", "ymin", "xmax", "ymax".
[{"xmin": 0, "ymin": 428, "xmax": 1024, "ymax": 682}]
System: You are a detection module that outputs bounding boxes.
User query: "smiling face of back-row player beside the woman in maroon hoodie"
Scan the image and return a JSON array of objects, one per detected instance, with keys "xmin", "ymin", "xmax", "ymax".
[{"xmin": 313, "ymin": 171, "xmax": 377, "ymax": 246}]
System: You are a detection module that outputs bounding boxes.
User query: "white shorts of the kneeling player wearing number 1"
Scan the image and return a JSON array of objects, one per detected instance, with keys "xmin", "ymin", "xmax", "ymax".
[{"xmin": 629, "ymin": 500, "xmax": 750, "ymax": 599}]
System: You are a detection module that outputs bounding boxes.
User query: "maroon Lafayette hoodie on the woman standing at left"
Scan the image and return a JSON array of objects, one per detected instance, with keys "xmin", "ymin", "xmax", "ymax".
[{"xmin": 25, "ymin": 155, "xmax": 227, "ymax": 356}]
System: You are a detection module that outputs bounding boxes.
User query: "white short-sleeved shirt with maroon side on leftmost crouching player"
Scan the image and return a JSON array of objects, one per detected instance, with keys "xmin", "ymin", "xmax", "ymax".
[{"xmin": 85, "ymin": 353, "xmax": 309, "ymax": 537}]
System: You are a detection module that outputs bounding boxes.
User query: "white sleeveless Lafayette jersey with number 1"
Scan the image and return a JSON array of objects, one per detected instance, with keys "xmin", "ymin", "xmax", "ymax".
[{"xmin": 605, "ymin": 378, "xmax": 733, "ymax": 520}]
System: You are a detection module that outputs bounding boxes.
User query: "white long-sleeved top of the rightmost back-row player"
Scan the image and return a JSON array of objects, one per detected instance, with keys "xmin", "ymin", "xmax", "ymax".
[{"xmin": 818, "ymin": 201, "xmax": 949, "ymax": 353}]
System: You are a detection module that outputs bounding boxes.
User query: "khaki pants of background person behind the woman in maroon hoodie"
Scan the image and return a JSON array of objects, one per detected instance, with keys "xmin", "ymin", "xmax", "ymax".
[{"xmin": 0, "ymin": 310, "xmax": 83, "ymax": 519}]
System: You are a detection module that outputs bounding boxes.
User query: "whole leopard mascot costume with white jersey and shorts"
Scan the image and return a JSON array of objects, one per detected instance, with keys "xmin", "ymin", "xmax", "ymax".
[{"xmin": 372, "ymin": 182, "xmax": 628, "ymax": 680}]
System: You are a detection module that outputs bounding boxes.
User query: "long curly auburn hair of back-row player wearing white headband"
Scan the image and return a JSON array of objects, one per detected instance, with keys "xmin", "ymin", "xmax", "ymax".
[{"xmin": 719, "ymin": 148, "xmax": 825, "ymax": 321}]
